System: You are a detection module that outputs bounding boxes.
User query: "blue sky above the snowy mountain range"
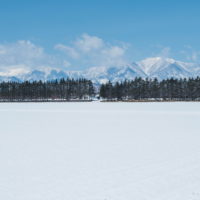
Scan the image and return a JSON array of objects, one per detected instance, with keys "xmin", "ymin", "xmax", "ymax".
[{"xmin": 0, "ymin": 0, "xmax": 200, "ymax": 72}]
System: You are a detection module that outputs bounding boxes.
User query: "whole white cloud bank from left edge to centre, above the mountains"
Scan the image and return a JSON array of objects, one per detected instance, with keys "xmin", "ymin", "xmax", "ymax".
[{"xmin": 0, "ymin": 34, "xmax": 130, "ymax": 76}]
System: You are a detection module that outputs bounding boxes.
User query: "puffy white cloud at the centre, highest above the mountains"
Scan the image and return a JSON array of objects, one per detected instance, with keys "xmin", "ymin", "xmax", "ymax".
[{"xmin": 55, "ymin": 34, "xmax": 128, "ymax": 67}]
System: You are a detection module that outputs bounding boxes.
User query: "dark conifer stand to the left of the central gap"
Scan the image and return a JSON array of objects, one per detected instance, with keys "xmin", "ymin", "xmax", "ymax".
[{"xmin": 0, "ymin": 79, "xmax": 94, "ymax": 101}]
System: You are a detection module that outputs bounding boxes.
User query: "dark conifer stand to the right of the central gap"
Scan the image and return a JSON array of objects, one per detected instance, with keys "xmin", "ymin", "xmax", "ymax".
[{"xmin": 100, "ymin": 77, "xmax": 200, "ymax": 101}]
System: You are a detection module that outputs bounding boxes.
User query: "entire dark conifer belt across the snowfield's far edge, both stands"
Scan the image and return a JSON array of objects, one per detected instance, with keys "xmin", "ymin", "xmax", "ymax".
[{"xmin": 0, "ymin": 77, "xmax": 200, "ymax": 102}]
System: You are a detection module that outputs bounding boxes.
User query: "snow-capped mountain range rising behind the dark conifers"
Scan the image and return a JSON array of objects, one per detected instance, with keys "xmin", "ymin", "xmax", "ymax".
[{"xmin": 0, "ymin": 57, "xmax": 200, "ymax": 83}]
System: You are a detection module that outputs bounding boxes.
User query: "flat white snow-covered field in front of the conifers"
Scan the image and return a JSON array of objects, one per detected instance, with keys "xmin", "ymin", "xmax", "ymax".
[{"xmin": 0, "ymin": 103, "xmax": 200, "ymax": 200}]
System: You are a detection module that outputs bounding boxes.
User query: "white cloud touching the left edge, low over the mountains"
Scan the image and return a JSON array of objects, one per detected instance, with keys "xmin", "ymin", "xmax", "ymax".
[{"xmin": 0, "ymin": 40, "xmax": 69, "ymax": 76}]
